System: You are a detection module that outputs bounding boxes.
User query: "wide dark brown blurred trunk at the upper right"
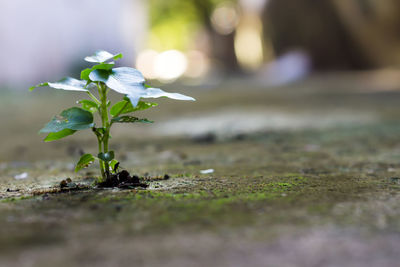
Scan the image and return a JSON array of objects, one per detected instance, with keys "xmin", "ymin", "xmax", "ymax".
[{"xmin": 263, "ymin": 0, "xmax": 372, "ymax": 70}]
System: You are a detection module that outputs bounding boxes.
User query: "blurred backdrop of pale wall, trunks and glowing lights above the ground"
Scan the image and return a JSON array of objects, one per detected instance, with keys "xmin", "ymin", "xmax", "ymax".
[{"xmin": 0, "ymin": 0, "xmax": 400, "ymax": 89}]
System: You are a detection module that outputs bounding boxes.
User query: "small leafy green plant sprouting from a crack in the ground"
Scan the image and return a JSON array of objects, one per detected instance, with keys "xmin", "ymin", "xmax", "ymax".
[{"xmin": 30, "ymin": 51, "xmax": 195, "ymax": 182}]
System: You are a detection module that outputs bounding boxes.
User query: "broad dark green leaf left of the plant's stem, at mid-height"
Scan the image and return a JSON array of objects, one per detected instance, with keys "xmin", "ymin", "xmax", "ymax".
[{"xmin": 40, "ymin": 107, "xmax": 94, "ymax": 133}]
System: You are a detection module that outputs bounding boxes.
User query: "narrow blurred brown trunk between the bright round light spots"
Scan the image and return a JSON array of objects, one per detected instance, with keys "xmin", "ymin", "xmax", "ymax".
[{"xmin": 192, "ymin": 0, "xmax": 240, "ymax": 72}]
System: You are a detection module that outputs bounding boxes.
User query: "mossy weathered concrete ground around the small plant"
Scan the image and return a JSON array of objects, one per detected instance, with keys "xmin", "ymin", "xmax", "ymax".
[{"xmin": 0, "ymin": 72, "xmax": 400, "ymax": 267}]
